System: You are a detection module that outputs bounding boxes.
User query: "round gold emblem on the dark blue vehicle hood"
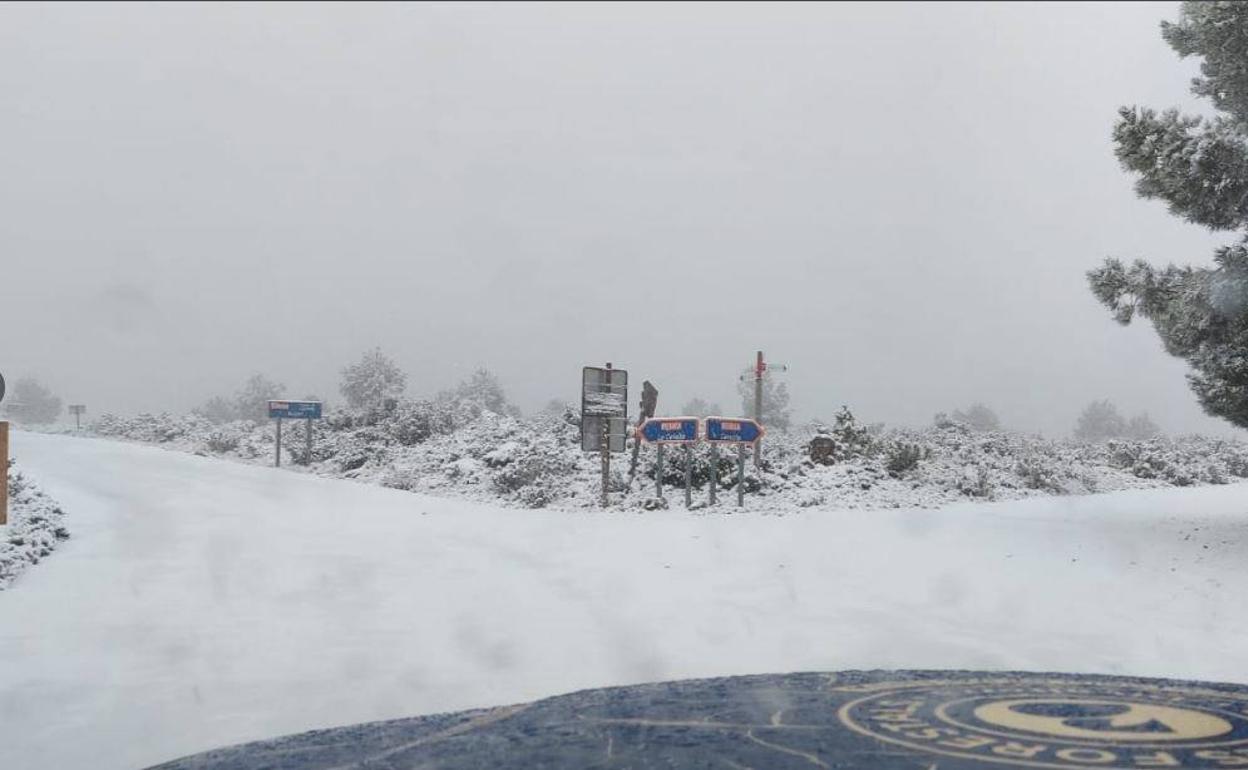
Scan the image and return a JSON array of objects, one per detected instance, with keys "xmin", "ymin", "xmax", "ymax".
[{"xmin": 839, "ymin": 676, "xmax": 1248, "ymax": 770}]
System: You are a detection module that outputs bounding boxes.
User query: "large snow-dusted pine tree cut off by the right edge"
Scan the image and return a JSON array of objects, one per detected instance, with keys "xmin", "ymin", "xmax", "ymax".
[{"xmin": 1088, "ymin": 2, "xmax": 1248, "ymax": 428}]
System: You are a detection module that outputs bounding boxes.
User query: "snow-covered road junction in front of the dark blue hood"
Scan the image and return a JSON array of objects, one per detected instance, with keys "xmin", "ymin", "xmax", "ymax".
[{"xmin": 0, "ymin": 433, "xmax": 1248, "ymax": 770}]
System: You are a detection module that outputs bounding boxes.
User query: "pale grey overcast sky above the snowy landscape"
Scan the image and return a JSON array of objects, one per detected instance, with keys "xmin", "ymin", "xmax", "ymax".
[{"xmin": 0, "ymin": 2, "xmax": 1228, "ymax": 433}]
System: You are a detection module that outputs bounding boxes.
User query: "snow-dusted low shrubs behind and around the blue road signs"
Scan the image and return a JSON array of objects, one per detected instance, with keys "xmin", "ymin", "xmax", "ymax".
[{"xmin": 90, "ymin": 394, "xmax": 1248, "ymax": 512}]
